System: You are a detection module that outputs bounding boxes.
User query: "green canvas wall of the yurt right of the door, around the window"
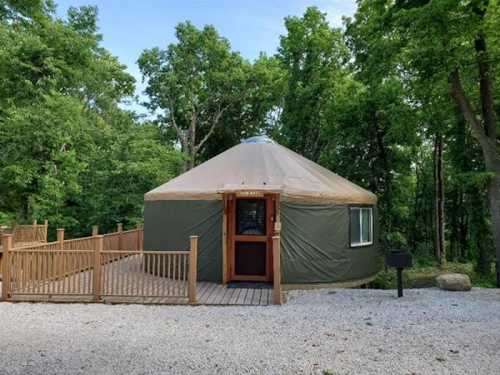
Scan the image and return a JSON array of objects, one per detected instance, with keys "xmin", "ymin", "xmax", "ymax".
[{"xmin": 281, "ymin": 202, "xmax": 381, "ymax": 284}]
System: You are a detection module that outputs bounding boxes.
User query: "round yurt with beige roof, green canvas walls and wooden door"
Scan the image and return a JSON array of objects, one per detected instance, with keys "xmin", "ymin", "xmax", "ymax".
[{"xmin": 144, "ymin": 136, "xmax": 380, "ymax": 286}]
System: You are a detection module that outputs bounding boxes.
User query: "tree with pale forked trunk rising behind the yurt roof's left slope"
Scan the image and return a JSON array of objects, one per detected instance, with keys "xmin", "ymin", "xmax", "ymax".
[{"xmin": 138, "ymin": 22, "xmax": 248, "ymax": 170}]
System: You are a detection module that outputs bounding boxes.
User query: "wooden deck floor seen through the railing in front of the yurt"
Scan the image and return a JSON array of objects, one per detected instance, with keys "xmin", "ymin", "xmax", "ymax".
[{"xmin": 0, "ymin": 250, "xmax": 273, "ymax": 306}]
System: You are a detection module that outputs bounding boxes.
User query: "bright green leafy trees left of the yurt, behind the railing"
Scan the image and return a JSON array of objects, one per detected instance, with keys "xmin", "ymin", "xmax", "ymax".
[{"xmin": 0, "ymin": 1, "xmax": 181, "ymax": 236}]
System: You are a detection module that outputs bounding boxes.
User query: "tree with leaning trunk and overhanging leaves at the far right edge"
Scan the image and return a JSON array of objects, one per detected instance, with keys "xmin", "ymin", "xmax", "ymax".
[{"xmin": 394, "ymin": 0, "xmax": 500, "ymax": 286}]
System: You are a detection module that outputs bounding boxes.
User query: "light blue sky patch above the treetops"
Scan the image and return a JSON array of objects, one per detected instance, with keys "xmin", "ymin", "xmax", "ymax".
[{"xmin": 56, "ymin": 0, "xmax": 356, "ymax": 113}]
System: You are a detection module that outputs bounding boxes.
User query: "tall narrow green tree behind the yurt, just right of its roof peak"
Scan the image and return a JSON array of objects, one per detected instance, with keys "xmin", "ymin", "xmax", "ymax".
[{"xmin": 277, "ymin": 7, "xmax": 348, "ymax": 161}]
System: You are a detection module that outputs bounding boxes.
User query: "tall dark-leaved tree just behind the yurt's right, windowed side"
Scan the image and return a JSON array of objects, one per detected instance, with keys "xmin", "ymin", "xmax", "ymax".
[{"xmin": 344, "ymin": 2, "xmax": 422, "ymax": 251}]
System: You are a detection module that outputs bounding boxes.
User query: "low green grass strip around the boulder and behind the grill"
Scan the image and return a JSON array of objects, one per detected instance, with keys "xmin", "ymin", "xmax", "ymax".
[{"xmin": 371, "ymin": 262, "xmax": 495, "ymax": 289}]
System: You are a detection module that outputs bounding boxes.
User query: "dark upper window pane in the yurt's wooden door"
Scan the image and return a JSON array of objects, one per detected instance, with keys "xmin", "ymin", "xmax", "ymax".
[{"xmin": 236, "ymin": 199, "xmax": 266, "ymax": 236}]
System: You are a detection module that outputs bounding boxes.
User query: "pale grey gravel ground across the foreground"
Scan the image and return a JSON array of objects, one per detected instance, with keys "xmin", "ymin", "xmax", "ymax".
[{"xmin": 0, "ymin": 289, "xmax": 500, "ymax": 374}]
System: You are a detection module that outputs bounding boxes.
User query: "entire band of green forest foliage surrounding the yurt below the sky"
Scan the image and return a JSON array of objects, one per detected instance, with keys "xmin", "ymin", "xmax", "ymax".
[{"xmin": 0, "ymin": 0, "xmax": 500, "ymax": 286}]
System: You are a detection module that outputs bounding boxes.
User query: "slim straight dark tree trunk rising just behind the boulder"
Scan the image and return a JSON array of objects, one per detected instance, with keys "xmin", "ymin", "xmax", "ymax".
[{"xmin": 434, "ymin": 134, "xmax": 446, "ymax": 266}]
